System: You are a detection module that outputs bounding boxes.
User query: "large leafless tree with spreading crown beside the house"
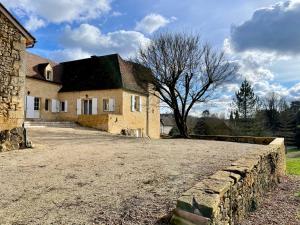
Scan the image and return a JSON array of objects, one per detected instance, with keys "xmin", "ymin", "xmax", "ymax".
[{"xmin": 137, "ymin": 33, "xmax": 236, "ymax": 137}]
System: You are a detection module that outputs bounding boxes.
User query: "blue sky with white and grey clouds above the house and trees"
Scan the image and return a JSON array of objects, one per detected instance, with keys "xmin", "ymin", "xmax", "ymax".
[{"xmin": 0, "ymin": 0, "xmax": 300, "ymax": 115}]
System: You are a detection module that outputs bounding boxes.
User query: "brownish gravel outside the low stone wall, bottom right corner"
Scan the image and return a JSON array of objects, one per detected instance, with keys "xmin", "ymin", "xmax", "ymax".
[{"xmin": 242, "ymin": 176, "xmax": 300, "ymax": 225}]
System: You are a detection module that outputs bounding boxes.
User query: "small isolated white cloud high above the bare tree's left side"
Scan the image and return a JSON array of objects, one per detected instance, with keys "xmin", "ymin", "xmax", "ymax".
[{"xmin": 135, "ymin": 13, "xmax": 172, "ymax": 34}]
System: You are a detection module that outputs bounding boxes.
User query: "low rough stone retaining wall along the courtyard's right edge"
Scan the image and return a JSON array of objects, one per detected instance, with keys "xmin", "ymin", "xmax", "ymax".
[{"xmin": 171, "ymin": 136, "xmax": 286, "ymax": 225}]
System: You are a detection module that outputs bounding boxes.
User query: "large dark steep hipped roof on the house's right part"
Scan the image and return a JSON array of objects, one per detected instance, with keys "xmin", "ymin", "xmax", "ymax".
[{"xmin": 60, "ymin": 54, "xmax": 151, "ymax": 94}]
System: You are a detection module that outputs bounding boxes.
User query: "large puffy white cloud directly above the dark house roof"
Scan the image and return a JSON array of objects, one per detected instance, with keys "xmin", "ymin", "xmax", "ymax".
[{"xmin": 53, "ymin": 23, "xmax": 150, "ymax": 60}]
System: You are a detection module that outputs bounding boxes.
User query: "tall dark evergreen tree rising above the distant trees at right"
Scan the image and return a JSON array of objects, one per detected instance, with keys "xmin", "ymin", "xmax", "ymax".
[{"xmin": 234, "ymin": 79, "xmax": 258, "ymax": 121}]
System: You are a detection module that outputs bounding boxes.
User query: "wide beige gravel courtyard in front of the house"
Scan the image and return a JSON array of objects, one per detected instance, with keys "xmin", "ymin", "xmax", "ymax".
[{"xmin": 0, "ymin": 128, "xmax": 261, "ymax": 225}]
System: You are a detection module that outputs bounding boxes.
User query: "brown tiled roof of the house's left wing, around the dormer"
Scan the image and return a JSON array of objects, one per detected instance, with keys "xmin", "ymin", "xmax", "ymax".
[{"xmin": 26, "ymin": 52, "xmax": 61, "ymax": 83}]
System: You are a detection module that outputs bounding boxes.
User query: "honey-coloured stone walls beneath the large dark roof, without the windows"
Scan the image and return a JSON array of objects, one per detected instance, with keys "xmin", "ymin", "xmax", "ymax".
[{"xmin": 58, "ymin": 89, "xmax": 160, "ymax": 139}]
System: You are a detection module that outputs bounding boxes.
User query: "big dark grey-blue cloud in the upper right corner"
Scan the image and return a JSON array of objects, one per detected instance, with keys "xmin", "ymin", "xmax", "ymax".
[{"xmin": 231, "ymin": 0, "xmax": 300, "ymax": 54}]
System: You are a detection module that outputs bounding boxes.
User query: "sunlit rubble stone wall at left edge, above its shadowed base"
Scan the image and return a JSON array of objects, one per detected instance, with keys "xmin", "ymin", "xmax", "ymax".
[{"xmin": 0, "ymin": 13, "xmax": 26, "ymax": 131}]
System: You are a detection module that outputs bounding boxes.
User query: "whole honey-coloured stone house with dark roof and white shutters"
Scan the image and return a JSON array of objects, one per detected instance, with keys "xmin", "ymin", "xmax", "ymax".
[{"xmin": 25, "ymin": 53, "xmax": 160, "ymax": 138}]
